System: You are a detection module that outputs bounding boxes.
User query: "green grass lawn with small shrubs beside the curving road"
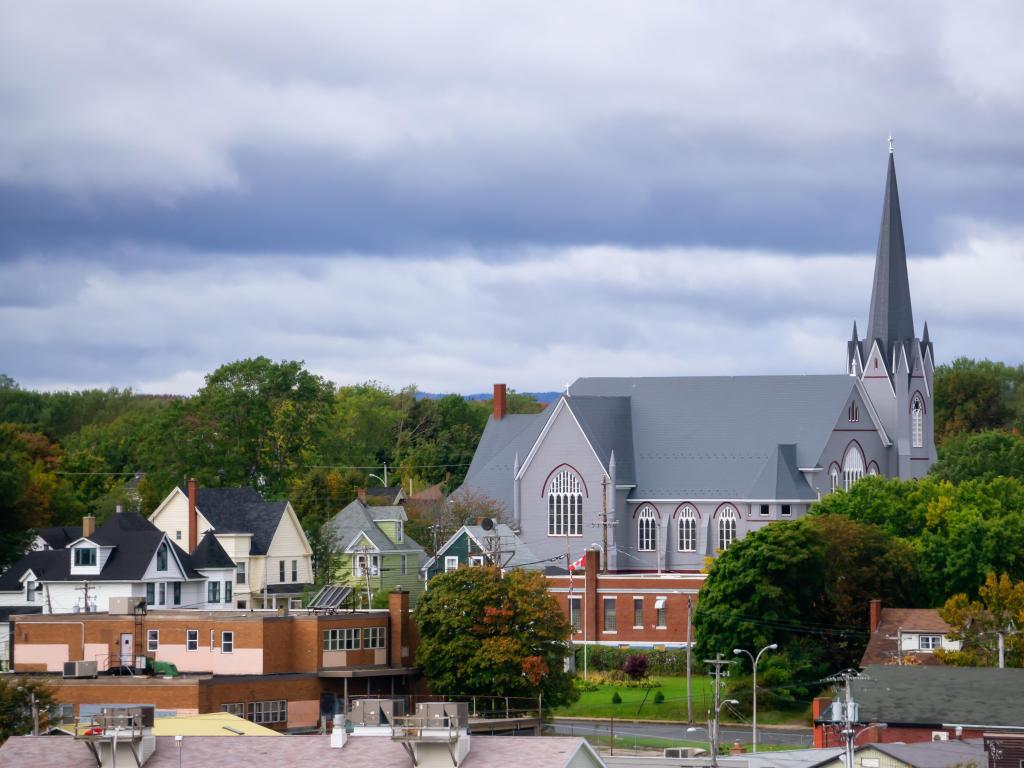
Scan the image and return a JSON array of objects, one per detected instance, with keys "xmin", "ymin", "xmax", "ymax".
[{"xmin": 554, "ymin": 675, "xmax": 810, "ymax": 725}]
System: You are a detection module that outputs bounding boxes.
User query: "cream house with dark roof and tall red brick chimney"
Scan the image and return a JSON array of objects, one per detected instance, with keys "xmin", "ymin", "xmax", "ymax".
[{"xmin": 150, "ymin": 480, "xmax": 313, "ymax": 608}]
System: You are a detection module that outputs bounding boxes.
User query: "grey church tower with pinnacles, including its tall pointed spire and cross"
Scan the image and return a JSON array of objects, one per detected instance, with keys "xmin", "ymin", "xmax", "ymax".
[{"xmin": 847, "ymin": 138, "xmax": 936, "ymax": 479}]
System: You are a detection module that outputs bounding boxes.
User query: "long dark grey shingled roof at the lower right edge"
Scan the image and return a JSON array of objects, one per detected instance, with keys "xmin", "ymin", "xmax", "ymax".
[{"xmin": 851, "ymin": 665, "xmax": 1024, "ymax": 728}]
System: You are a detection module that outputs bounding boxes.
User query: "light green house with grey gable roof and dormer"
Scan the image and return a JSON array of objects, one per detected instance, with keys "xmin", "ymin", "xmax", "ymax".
[{"xmin": 323, "ymin": 489, "xmax": 427, "ymax": 606}]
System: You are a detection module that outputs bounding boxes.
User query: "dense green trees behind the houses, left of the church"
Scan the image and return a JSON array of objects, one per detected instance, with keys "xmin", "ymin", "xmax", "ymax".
[{"xmin": 0, "ymin": 357, "xmax": 543, "ymax": 568}]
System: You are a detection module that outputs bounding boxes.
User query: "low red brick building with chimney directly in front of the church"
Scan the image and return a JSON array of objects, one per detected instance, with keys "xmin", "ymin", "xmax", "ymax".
[{"xmin": 548, "ymin": 549, "xmax": 705, "ymax": 648}]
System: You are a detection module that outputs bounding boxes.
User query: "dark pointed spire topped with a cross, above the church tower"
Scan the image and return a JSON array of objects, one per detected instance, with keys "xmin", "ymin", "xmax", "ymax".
[{"xmin": 864, "ymin": 138, "xmax": 914, "ymax": 356}]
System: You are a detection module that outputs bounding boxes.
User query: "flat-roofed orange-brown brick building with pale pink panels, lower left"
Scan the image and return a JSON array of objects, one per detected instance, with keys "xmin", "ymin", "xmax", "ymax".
[{"xmin": 11, "ymin": 592, "xmax": 416, "ymax": 729}]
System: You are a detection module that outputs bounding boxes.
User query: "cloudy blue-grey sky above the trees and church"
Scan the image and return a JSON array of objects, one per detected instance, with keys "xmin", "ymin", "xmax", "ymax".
[{"xmin": 0, "ymin": 0, "xmax": 1024, "ymax": 392}]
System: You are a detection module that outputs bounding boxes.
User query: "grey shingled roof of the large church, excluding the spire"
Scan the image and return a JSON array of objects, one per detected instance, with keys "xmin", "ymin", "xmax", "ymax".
[{"xmin": 465, "ymin": 375, "xmax": 856, "ymax": 510}]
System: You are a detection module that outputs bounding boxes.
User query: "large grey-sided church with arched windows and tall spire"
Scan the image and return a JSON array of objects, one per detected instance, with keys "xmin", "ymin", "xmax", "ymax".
[{"xmin": 464, "ymin": 150, "xmax": 936, "ymax": 572}]
